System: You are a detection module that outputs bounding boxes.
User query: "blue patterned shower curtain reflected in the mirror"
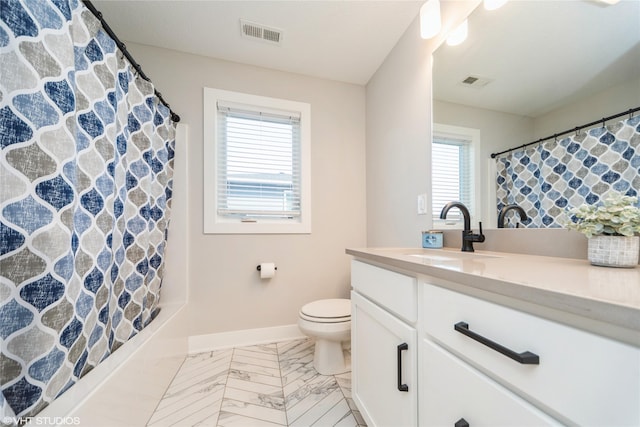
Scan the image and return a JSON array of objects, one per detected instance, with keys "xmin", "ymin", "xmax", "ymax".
[{"xmin": 496, "ymin": 117, "xmax": 640, "ymax": 228}]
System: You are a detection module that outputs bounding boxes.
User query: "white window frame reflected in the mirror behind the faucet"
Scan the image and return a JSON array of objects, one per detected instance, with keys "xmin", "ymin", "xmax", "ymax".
[{"xmin": 430, "ymin": 123, "xmax": 482, "ymax": 229}]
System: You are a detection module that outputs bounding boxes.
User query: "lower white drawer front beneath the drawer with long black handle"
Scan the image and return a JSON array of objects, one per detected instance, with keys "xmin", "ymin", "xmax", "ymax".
[{"xmin": 420, "ymin": 339, "xmax": 560, "ymax": 427}]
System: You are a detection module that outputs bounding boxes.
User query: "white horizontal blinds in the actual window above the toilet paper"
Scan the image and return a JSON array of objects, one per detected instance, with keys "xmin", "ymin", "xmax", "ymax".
[{"xmin": 216, "ymin": 101, "xmax": 301, "ymax": 219}]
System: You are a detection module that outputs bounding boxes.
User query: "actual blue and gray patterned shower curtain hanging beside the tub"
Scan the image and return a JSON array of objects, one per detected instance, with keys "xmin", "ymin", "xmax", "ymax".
[{"xmin": 0, "ymin": 0, "xmax": 175, "ymax": 423}]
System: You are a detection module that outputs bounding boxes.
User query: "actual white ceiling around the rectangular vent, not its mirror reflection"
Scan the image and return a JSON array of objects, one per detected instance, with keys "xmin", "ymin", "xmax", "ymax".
[{"xmin": 92, "ymin": 0, "xmax": 424, "ymax": 85}]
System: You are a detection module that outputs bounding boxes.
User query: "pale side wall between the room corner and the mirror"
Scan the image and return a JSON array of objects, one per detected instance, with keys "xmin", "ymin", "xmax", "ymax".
[{"xmin": 367, "ymin": 0, "xmax": 479, "ymax": 247}]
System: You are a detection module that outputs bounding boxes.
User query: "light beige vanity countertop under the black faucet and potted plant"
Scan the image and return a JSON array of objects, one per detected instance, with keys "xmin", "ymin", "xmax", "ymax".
[{"xmin": 346, "ymin": 248, "xmax": 640, "ymax": 341}]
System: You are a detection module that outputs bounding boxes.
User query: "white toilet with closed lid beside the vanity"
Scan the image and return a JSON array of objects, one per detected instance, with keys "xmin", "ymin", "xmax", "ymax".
[{"xmin": 298, "ymin": 299, "xmax": 351, "ymax": 375}]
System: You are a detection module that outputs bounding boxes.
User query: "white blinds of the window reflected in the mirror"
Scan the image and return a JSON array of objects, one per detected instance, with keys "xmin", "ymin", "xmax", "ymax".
[{"xmin": 431, "ymin": 135, "xmax": 474, "ymax": 220}]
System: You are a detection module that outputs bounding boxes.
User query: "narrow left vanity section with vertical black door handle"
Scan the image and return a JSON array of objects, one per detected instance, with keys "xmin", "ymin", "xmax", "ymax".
[{"xmin": 351, "ymin": 261, "xmax": 418, "ymax": 427}]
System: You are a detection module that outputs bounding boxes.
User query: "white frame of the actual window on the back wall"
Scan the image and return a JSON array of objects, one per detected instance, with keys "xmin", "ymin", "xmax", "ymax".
[{"xmin": 203, "ymin": 87, "xmax": 311, "ymax": 234}]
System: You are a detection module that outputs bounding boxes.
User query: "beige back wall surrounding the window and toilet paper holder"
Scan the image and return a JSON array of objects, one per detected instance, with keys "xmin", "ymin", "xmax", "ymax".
[{"xmin": 127, "ymin": 44, "xmax": 366, "ymax": 335}]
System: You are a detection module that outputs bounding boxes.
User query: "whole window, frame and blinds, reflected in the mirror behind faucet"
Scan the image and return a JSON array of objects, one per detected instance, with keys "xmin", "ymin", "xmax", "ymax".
[{"xmin": 431, "ymin": 124, "xmax": 480, "ymax": 226}]
